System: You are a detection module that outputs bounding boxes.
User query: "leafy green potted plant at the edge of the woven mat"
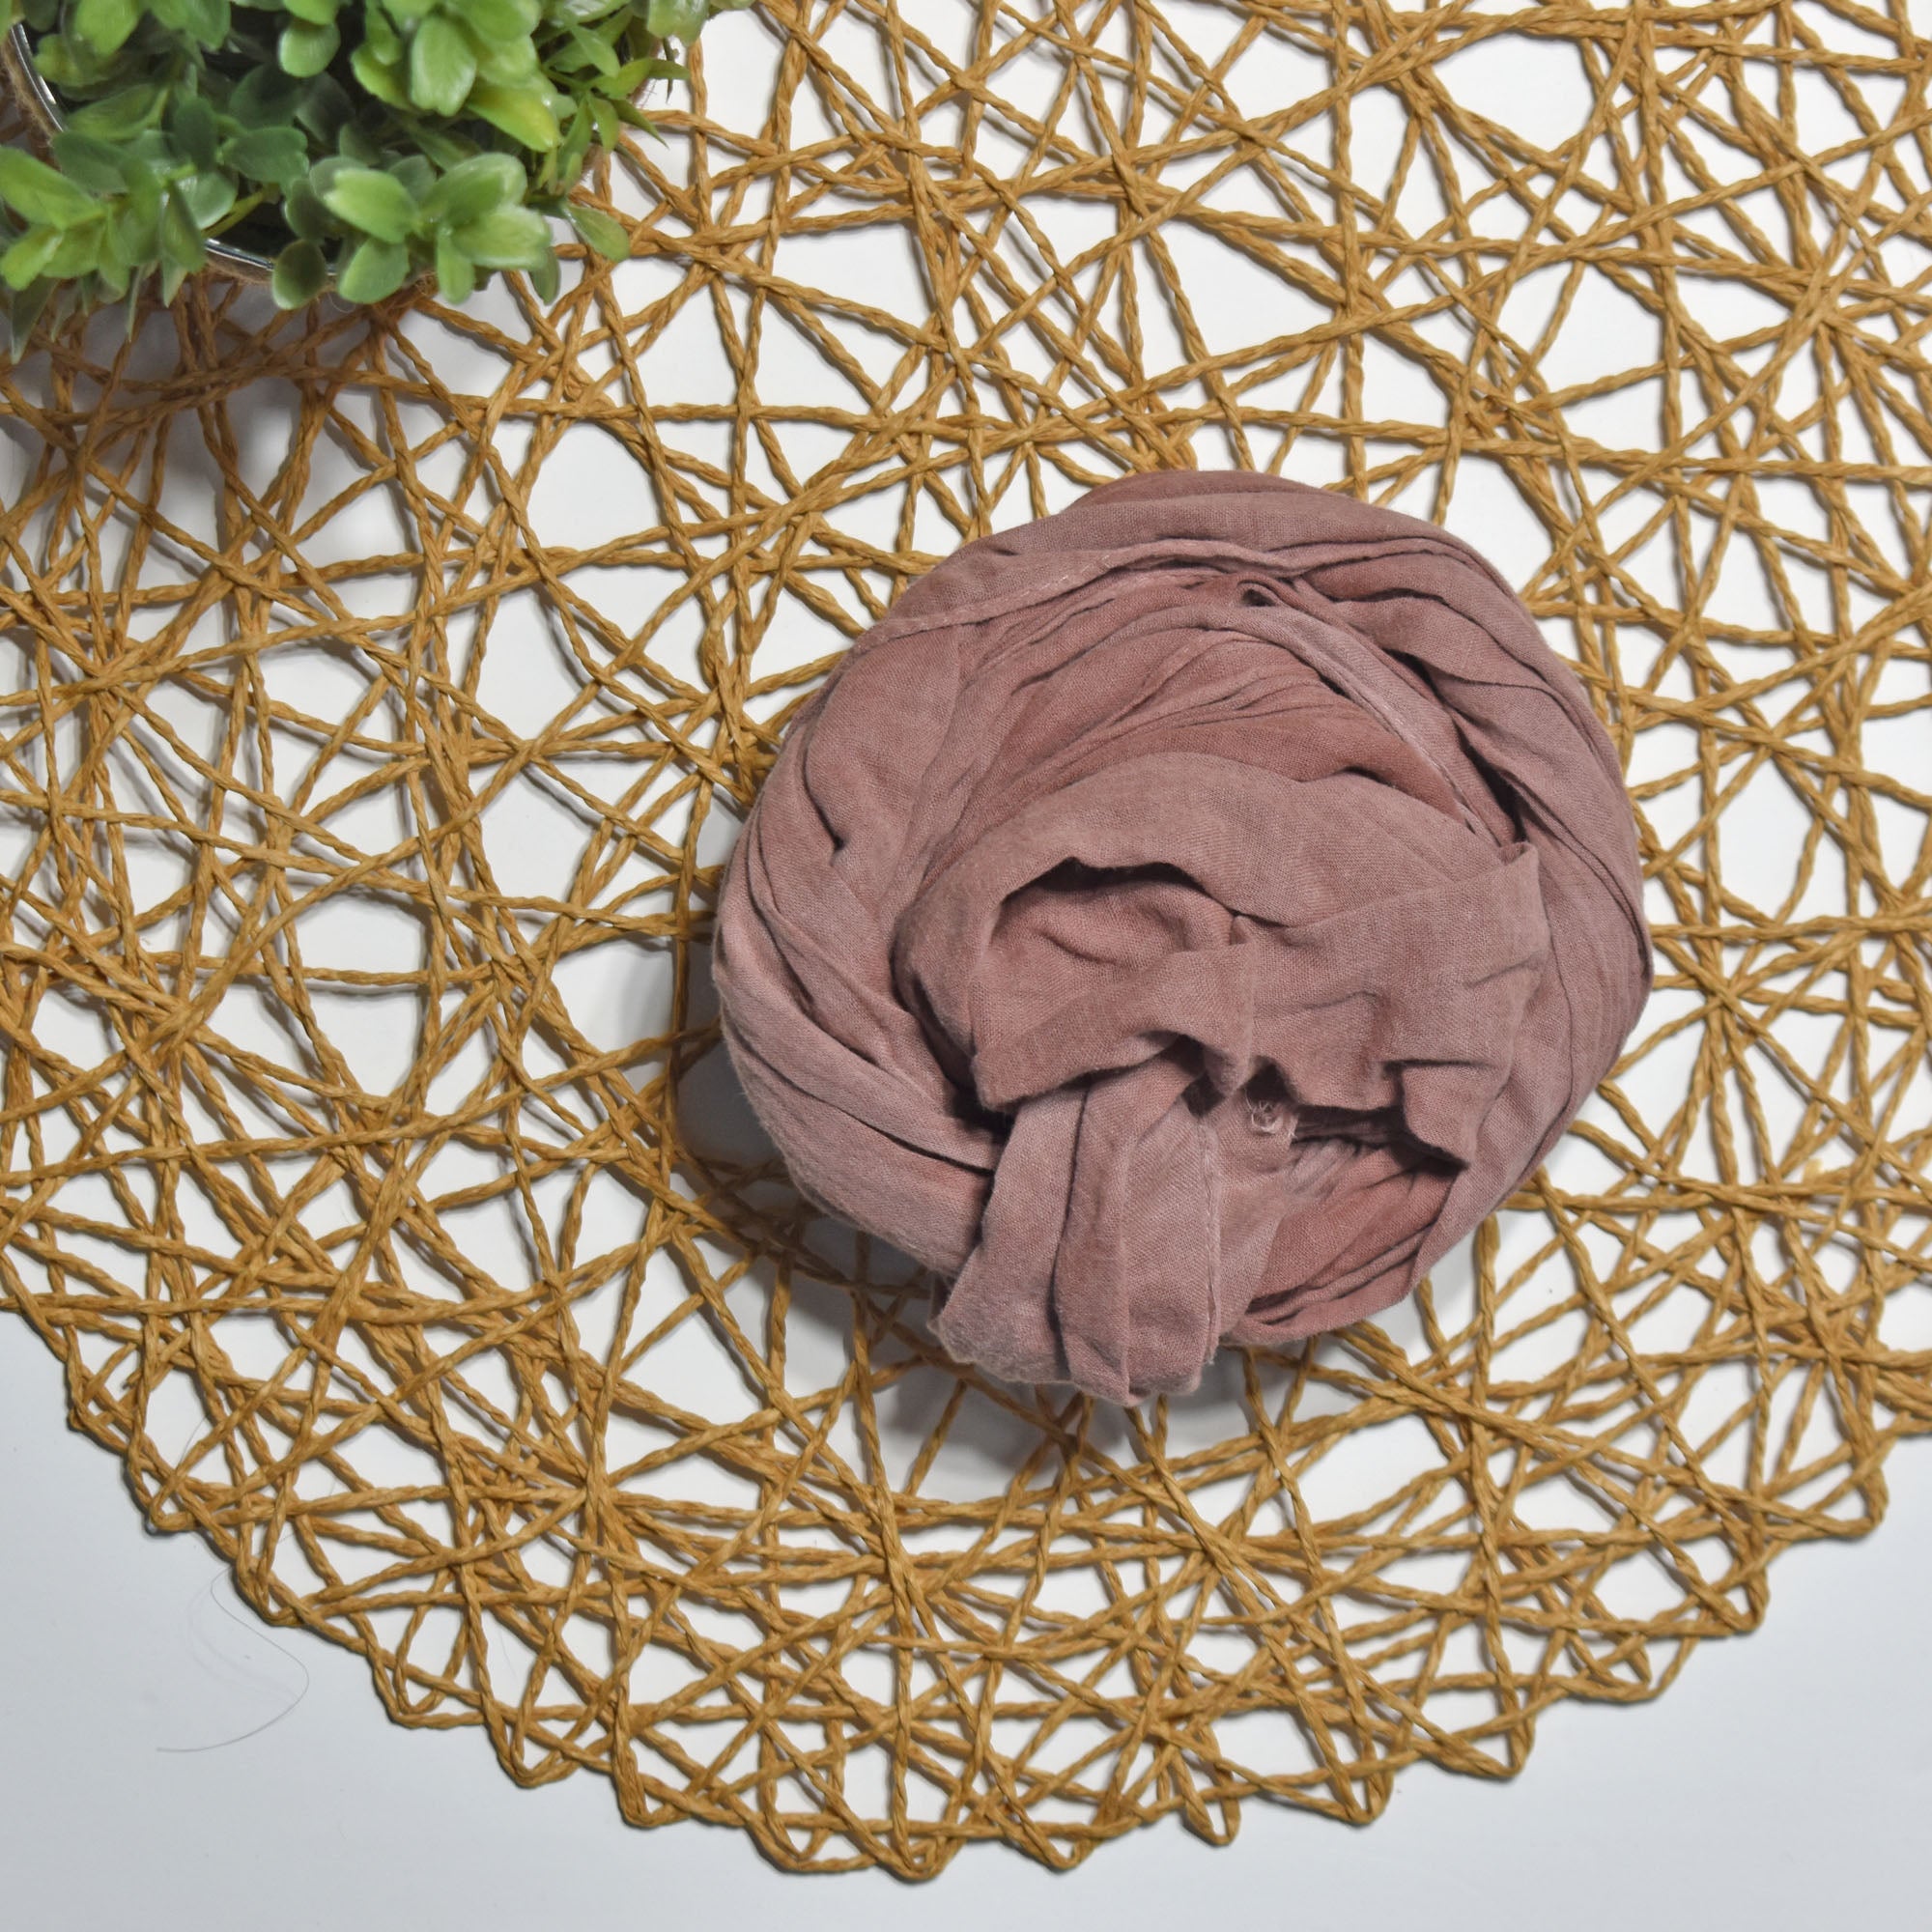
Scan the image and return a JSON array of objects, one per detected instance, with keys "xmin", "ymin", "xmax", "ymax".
[{"xmin": 0, "ymin": 0, "xmax": 748, "ymax": 346}]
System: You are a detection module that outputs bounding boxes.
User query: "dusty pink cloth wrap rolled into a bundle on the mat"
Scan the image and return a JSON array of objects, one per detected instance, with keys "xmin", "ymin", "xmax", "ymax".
[{"xmin": 717, "ymin": 473, "xmax": 1650, "ymax": 1401}]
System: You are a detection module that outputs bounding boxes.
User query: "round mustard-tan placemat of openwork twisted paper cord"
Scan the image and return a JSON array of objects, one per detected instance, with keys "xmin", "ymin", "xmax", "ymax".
[{"xmin": 0, "ymin": 0, "xmax": 1932, "ymax": 1874}]
